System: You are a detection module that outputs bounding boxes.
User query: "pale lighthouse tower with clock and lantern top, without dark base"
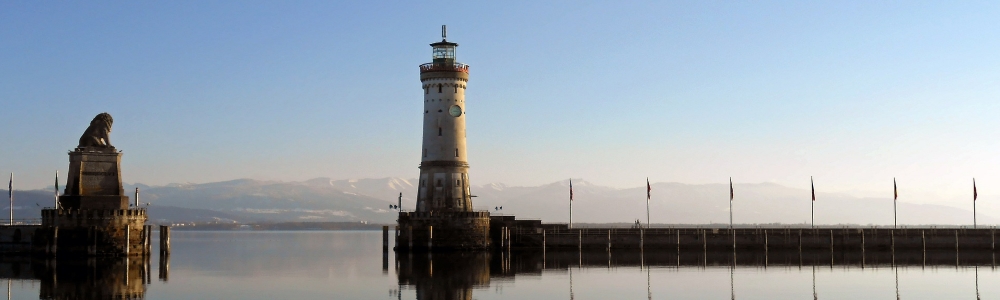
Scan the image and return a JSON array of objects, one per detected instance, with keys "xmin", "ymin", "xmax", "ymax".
[{"xmin": 417, "ymin": 26, "xmax": 472, "ymax": 212}]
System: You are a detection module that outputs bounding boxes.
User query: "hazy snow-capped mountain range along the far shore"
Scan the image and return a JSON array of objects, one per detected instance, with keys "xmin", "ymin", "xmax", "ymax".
[{"xmin": 4, "ymin": 178, "xmax": 1000, "ymax": 225}]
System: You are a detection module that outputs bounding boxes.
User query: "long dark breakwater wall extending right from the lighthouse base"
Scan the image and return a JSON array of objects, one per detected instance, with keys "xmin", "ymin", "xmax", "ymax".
[{"xmin": 491, "ymin": 227, "xmax": 997, "ymax": 251}]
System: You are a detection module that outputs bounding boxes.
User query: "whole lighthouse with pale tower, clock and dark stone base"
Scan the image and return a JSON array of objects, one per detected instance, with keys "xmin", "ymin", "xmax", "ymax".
[{"xmin": 395, "ymin": 26, "xmax": 490, "ymax": 251}]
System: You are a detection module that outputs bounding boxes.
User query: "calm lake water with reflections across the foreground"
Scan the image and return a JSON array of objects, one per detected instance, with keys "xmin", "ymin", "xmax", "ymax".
[{"xmin": 3, "ymin": 231, "xmax": 1000, "ymax": 299}]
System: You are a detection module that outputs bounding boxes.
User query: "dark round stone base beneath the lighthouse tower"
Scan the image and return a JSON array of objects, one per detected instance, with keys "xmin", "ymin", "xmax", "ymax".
[{"xmin": 396, "ymin": 211, "xmax": 490, "ymax": 251}]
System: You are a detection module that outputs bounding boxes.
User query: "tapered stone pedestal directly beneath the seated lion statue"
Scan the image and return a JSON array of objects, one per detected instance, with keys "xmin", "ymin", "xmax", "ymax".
[{"xmin": 59, "ymin": 147, "xmax": 128, "ymax": 209}]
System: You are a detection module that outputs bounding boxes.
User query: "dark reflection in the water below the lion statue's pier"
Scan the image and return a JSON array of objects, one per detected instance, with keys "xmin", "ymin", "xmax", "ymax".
[{"xmin": 0, "ymin": 257, "xmax": 150, "ymax": 299}]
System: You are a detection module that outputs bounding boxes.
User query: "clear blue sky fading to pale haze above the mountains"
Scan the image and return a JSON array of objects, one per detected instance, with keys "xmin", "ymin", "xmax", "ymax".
[{"xmin": 0, "ymin": 1, "xmax": 1000, "ymax": 209}]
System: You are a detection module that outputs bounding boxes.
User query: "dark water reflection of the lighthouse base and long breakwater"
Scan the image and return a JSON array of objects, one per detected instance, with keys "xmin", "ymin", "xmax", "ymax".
[{"xmin": 396, "ymin": 250, "xmax": 996, "ymax": 299}]
